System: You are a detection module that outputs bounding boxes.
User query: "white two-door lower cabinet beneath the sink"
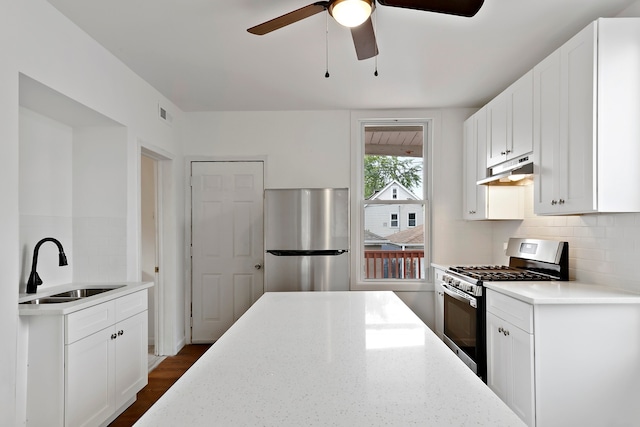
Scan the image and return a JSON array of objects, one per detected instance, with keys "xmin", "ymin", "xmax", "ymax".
[{"xmin": 27, "ymin": 290, "xmax": 148, "ymax": 427}]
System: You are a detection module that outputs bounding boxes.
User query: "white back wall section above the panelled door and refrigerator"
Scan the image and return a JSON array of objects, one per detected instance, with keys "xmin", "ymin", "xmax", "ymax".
[{"xmin": 184, "ymin": 111, "xmax": 350, "ymax": 188}]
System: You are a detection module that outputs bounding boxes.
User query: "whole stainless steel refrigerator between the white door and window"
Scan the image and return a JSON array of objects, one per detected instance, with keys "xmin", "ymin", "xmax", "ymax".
[{"xmin": 264, "ymin": 188, "xmax": 349, "ymax": 292}]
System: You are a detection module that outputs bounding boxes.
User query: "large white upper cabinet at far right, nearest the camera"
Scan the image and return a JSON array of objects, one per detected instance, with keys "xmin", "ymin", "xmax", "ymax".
[{"xmin": 533, "ymin": 18, "xmax": 640, "ymax": 215}]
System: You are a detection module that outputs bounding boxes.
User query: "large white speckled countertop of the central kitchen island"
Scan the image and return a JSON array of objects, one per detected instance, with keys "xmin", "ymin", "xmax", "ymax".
[{"xmin": 136, "ymin": 292, "xmax": 523, "ymax": 427}]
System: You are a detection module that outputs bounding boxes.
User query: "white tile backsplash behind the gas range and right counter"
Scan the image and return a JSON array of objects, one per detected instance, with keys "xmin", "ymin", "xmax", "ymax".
[{"xmin": 493, "ymin": 187, "xmax": 640, "ymax": 292}]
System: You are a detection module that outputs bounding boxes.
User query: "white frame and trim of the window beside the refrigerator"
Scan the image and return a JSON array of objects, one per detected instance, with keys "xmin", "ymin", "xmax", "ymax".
[{"xmin": 351, "ymin": 110, "xmax": 441, "ymax": 291}]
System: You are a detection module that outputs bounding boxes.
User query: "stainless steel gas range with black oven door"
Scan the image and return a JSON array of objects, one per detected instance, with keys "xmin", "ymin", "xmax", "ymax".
[{"xmin": 440, "ymin": 238, "xmax": 569, "ymax": 381}]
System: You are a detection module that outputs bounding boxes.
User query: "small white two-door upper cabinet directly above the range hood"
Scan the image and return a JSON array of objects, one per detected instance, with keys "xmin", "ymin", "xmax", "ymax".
[{"xmin": 485, "ymin": 71, "xmax": 533, "ymax": 167}]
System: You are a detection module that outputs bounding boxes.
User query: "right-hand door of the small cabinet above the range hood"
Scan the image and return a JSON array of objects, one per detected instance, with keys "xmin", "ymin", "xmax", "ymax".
[{"xmin": 507, "ymin": 71, "xmax": 533, "ymax": 159}]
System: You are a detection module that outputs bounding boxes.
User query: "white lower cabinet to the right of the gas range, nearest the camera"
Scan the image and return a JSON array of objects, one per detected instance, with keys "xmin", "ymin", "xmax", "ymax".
[{"xmin": 486, "ymin": 285, "xmax": 640, "ymax": 427}]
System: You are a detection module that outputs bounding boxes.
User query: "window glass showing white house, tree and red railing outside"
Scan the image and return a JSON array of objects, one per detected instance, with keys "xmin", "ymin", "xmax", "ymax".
[{"xmin": 363, "ymin": 126, "xmax": 428, "ymax": 280}]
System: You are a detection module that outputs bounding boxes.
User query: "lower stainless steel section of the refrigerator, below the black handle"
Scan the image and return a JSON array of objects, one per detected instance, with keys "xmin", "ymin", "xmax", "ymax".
[{"xmin": 264, "ymin": 252, "xmax": 349, "ymax": 292}]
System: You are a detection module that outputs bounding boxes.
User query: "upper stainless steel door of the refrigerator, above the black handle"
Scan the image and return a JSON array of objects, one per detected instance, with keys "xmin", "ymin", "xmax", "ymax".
[{"xmin": 265, "ymin": 188, "xmax": 349, "ymax": 250}]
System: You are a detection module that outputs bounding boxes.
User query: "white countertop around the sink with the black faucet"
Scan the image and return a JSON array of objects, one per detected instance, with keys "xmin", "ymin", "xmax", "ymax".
[{"xmin": 18, "ymin": 282, "xmax": 153, "ymax": 316}]
